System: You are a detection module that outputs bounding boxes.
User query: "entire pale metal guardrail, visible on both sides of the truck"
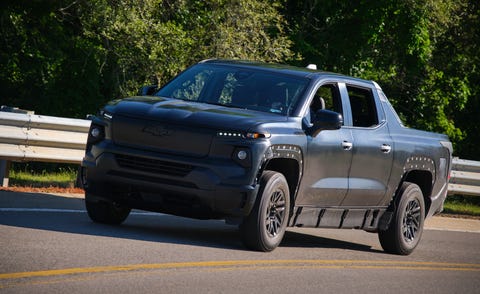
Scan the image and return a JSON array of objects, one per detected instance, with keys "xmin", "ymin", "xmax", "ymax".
[{"xmin": 0, "ymin": 111, "xmax": 480, "ymax": 196}]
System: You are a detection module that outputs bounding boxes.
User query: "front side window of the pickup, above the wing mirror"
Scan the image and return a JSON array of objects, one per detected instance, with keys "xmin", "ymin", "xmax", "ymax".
[{"xmin": 310, "ymin": 84, "xmax": 343, "ymax": 121}]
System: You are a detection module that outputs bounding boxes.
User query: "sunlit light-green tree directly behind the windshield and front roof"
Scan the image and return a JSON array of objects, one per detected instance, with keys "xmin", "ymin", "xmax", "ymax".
[{"xmin": 81, "ymin": 0, "xmax": 293, "ymax": 96}]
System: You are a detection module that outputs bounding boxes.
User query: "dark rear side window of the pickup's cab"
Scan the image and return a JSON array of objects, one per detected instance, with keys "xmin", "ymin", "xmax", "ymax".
[{"xmin": 347, "ymin": 85, "xmax": 378, "ymax": 128}]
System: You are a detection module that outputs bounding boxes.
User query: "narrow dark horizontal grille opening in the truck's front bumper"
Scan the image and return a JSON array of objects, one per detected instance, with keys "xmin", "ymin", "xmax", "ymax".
[{"xmin": 115, "ymin": 154, "xmax": 193, "ymax": 177}]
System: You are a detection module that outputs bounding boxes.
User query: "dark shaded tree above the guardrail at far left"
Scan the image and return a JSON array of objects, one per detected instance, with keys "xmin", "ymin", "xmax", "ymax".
[{"xmin": 0, "ymin": 1, "xmax": 102, "ymax": 118}]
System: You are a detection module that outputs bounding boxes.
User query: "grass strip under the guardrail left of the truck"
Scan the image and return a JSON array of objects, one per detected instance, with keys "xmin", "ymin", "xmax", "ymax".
[{"xmin": 9, "ymin": 168, "xmax": 77, "ymax": 188}]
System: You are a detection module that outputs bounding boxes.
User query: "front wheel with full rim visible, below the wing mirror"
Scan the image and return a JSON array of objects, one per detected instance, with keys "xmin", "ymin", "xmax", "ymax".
[{"xmin": 240, "ymin": 171, "xmax": 290, "ymax": 252}]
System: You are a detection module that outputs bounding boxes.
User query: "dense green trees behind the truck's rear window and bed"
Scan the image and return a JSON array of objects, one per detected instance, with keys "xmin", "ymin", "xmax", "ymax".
[{"xmin": 285, "ymin": 0, "xmax": 479, "ymax": 156}]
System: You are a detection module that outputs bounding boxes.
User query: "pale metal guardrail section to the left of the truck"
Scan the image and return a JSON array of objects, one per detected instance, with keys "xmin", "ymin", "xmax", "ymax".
[{"xmin": 0, "ymin": 107, "xmax": 90, "ymax": 187}]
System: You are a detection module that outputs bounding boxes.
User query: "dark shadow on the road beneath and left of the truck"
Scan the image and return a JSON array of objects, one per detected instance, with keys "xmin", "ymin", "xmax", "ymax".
[{"xmin": 0, "ymin": 191, "xmax": 377, "ymax": 252}]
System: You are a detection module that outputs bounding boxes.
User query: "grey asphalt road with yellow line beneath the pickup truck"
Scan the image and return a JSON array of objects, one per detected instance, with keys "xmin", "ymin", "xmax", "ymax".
[{"xmin": 0, "ymin": 191, "xmax": 480, "ymax": 293}]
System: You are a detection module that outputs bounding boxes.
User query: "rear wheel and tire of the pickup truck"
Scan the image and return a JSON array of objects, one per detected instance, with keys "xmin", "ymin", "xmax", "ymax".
[{"xmin": 378, "ymin": 182, "xmax": 425, "ymax": 255}]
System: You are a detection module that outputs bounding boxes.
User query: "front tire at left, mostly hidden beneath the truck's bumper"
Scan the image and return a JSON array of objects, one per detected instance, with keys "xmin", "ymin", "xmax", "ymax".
[{"xmin": 85, "ymin": 193, "xmax": 131, "ymax": 225}]
